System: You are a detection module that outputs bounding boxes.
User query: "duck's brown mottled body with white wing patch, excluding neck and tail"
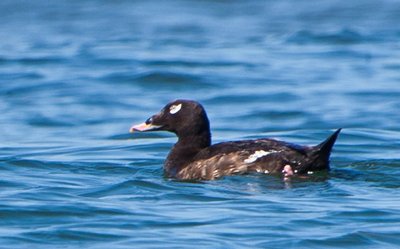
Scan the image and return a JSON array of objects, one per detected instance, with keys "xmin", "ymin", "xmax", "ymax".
[{"xmin": 177, "ymin": 138, "xmax": 312, "ymax": 180}]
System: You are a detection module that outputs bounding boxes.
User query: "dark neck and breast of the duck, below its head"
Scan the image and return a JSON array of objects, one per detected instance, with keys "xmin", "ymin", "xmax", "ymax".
[{"xmin": 164, "ymin": 130, "xmax": 211, "ymax": 177}]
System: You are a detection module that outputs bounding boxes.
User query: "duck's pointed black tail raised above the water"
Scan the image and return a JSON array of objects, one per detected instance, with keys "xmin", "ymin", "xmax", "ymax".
[{"xmin": 303, "ymin": 128, "xmax": 342, "ymax": 173}]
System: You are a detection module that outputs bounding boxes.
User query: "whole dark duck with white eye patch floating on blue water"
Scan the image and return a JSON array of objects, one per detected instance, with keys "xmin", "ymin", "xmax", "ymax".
[{"xmin": 129, "ymin": 99, "xmax": 341, "ymax": 181}]
